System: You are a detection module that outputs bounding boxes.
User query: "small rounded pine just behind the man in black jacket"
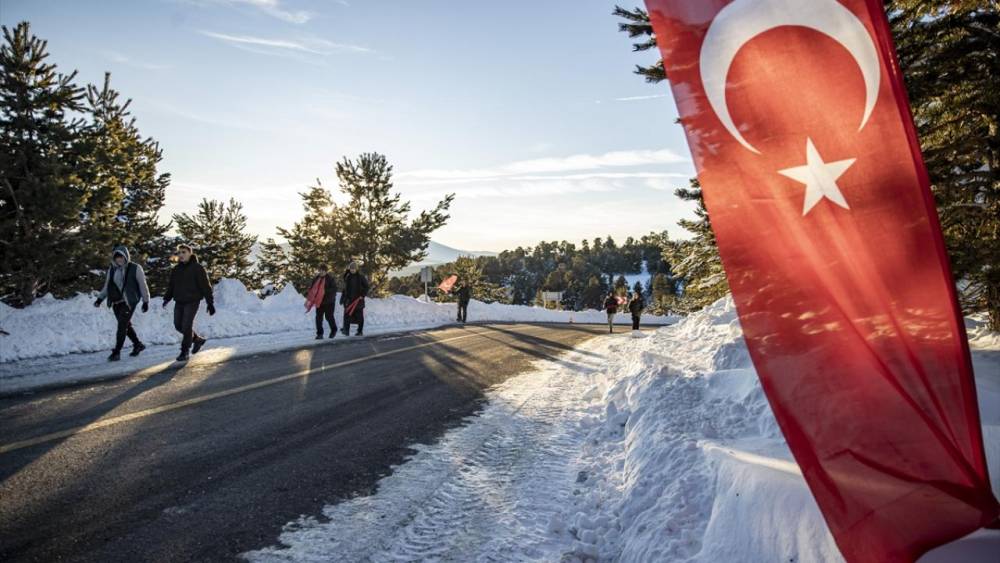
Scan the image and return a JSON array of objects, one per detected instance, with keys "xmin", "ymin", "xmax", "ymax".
[{"xmin": 174, "ymin": 199, "xmax": 257, "ymax": 287}]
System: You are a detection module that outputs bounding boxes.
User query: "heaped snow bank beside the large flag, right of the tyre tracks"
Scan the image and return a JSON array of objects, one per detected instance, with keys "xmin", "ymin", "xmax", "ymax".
[{"xmin": 565, "ymin": 299, "xmax": 1000, "ymax": 562}]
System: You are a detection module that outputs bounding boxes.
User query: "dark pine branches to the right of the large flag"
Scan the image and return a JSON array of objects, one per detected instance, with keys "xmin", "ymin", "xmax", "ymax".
[{"xmin": 886, "ymin": 0, "xmax": 1000, "ymax": 330}]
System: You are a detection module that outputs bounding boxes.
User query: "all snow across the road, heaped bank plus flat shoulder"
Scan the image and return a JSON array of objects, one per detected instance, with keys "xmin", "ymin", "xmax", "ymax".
[{"xmin": 0, "ymin": 279, "xmax": 676, "ymax": 394}]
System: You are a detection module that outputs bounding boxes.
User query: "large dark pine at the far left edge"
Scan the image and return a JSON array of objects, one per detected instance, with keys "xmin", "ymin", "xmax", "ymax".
[{"xmin": 0, "ymin": 22, "xmax": 94, "ymax": 305}]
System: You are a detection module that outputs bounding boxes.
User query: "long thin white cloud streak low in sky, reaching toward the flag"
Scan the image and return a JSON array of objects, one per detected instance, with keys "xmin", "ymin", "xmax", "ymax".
[{"xmin": 399, "ymin": 149, "xmax": 687, "ymax": 180}]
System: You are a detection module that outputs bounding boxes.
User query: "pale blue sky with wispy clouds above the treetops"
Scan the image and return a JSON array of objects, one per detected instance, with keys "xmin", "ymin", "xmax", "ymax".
[{"xmin": 0, "ymin": 0, "xmax": 693, "ymax": 250}]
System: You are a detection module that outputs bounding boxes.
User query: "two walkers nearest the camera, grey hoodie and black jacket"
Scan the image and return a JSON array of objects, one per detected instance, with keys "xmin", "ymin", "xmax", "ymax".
[{"xmin": 94, "ymin": 244, "xmax": 215, "ymax": 362}]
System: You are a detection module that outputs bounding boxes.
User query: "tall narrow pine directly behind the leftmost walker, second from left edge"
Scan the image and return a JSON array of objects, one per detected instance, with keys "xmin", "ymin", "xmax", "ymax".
[{"xmin": 87, "ymin": 73, "xmax": 174, "ymax": 293}]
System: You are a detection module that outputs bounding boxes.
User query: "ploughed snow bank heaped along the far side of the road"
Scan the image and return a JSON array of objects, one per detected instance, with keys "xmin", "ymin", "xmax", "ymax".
[{"xmin": 0, "ymin": 279, "xmax": 673, "ymax": 363}]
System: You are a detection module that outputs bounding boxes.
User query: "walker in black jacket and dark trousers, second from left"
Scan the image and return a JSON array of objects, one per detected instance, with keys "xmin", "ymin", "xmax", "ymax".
[{"xmin": 163, "ymin": 244, "xmax": 215, "ymax": 362}]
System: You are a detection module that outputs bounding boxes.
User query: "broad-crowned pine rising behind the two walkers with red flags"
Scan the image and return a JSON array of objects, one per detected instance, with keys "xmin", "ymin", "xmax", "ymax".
[{"xmin": 333, "ymin": 153, "xmax": 455, "ymax": 294}]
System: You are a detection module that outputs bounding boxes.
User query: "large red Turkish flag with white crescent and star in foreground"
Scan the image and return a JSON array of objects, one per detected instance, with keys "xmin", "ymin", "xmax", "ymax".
[{"xmin": 646, "ymin": 0, "xmax": 998, "ymax": 563}]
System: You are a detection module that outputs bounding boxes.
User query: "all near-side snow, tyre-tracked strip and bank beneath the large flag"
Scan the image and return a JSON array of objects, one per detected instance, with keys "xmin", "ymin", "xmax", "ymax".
[{"xmin": 245, "ymin": 301, "xmax": 1000, "ymax": 562}]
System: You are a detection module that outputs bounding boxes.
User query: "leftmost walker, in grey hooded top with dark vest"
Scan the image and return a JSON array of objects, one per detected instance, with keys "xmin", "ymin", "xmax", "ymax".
[{"xmin": 94, "ymin": 246, "xmax": 149, "ymax": 362}]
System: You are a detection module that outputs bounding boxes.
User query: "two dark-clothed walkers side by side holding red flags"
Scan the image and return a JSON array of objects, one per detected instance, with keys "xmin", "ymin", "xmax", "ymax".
[{"xmin": 306, "ymin": 261, "xmax": 371, "ymax": 340}]
